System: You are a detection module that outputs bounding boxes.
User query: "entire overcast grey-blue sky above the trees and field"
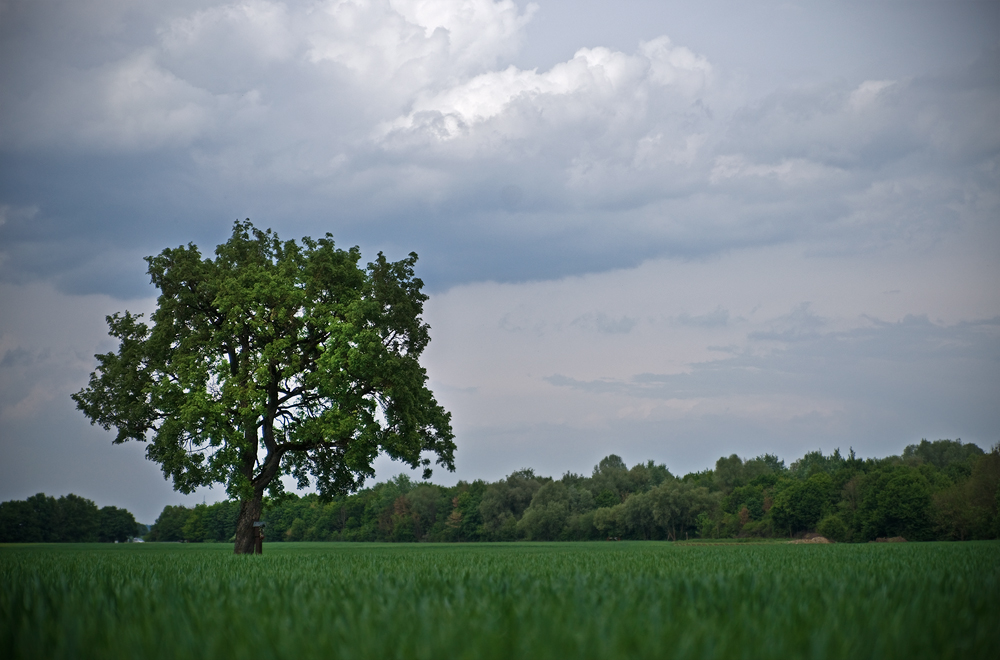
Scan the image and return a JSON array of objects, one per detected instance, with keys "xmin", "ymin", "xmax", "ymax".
[{"xmin": 0, "ymin": 0, "xmax": 1000, "ymax": 522}]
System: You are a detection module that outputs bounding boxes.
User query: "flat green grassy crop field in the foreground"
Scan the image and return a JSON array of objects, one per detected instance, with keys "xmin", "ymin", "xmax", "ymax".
[{"xmin": 0, "ymin": 542, "xmax": 1000, "ymax": 660}]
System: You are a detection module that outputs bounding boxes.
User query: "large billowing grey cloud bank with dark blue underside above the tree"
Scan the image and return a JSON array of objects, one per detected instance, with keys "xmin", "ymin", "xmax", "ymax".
[{"xmin": 0, "ymin": 0, "xmax": 1000, "ymax": 286}]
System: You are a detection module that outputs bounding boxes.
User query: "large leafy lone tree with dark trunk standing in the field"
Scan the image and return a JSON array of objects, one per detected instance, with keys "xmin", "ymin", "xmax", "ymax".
[{"xmin": 73, "ymin": 220, "xmax": 455, "ymax": 554}]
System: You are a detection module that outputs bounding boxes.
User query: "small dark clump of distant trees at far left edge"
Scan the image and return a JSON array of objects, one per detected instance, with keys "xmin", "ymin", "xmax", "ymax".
[{"xmin": 0, "ymin": 493, "xmax": 146, "ymax": 543}]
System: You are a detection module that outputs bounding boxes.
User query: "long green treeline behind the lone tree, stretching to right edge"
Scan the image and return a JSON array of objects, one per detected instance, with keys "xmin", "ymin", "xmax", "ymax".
[{"xmin": 147, "ymin": 440, "xmax": 1000, "ymax": 542}]
